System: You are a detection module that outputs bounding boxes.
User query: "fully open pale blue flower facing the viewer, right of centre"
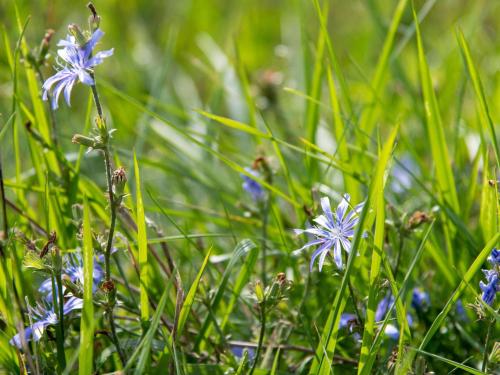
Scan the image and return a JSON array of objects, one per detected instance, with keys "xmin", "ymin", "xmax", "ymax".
[{"xmin": 295, "ymin": 194, "xmax": 364, "ymax": 272}]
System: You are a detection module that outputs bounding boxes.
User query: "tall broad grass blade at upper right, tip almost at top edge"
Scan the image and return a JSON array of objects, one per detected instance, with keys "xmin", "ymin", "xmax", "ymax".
[{"xmin": 413, "ymin": 5, "xmax": 459, "ymax": 212}]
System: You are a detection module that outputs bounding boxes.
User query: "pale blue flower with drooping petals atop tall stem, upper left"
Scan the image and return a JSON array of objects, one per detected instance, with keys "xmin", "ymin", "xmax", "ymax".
[{"xmin": 42, "ymin": 29, "xmax": 113, "ymax": 109}]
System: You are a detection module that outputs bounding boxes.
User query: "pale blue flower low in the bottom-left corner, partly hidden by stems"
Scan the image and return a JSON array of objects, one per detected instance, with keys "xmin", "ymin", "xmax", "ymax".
[{"xmin": 9, "ymin": 297, "xmax": 83, "ymax": 349}]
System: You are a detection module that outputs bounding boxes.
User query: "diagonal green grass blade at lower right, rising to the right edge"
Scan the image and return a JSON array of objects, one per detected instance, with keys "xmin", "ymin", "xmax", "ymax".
[{"xmin": 419, "ymin": 232, "xmax": 500, "ymax": 350}]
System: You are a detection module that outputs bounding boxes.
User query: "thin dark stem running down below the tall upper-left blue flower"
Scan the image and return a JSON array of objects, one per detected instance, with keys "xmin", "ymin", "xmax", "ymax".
[{"xmin": 91, "ymin": 80, "xmax": 127, "ymax": 366}]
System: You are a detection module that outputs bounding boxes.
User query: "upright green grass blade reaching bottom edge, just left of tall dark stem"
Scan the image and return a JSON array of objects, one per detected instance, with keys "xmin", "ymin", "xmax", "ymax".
[{"xmin": 78, "ymin": 198, "xmax": 94, "ymax": 375}]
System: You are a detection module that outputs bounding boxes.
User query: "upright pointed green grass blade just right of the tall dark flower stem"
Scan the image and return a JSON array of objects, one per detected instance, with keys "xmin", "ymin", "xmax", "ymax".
[{"xmin": 134, "ymin": 153, "xmax": 151, "ymax": 331}]
